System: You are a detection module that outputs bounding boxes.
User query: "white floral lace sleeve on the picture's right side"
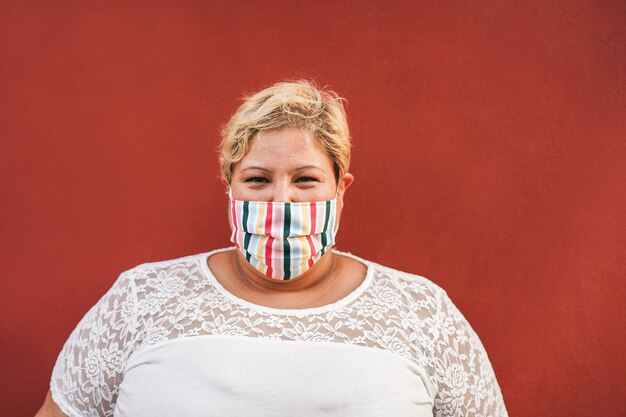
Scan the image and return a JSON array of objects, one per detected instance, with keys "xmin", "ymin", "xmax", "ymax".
[{"xmin": 431, "ymin": 290, "xmax": 508, "ymax": 417}]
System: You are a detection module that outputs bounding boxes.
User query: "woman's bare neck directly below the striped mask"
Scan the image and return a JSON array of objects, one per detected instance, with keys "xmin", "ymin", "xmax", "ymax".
[{"xmin": 231, "ymin": 249, "xmax": 340, "ymax": 294}]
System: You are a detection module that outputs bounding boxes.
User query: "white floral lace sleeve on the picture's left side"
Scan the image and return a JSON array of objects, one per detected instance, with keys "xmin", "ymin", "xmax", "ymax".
[{"xmin": 50, "ymin": 269, "xmax": 139, "ymax": 417}]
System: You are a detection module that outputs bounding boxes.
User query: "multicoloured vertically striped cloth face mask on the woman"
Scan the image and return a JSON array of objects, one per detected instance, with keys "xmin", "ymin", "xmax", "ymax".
[{"xmin": 229, "ymin": 190, "xmax": 339, "ymax": 280}]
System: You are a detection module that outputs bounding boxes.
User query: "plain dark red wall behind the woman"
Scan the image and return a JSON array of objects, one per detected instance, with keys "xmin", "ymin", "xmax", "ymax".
[{"xmin": 0, "ymin": 0, "xmax": 626, "ymax": 417}]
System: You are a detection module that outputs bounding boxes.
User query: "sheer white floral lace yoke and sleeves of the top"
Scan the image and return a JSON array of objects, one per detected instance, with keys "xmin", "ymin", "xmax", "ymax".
[{"xmin": 51, "ymin": 250, "xmax": 508, "ymax": 417}]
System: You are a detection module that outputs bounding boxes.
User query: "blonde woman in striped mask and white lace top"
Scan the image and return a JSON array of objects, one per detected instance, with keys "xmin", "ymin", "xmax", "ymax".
[{"xmin": 38, "ymin": 81, "xmax": 507, "ymax": 417}]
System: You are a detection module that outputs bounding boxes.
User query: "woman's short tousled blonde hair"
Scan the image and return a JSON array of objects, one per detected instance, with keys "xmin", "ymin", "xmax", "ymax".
[{"xmin": 219, "ymin": 80, "xmax": 351, "ymax": 184}]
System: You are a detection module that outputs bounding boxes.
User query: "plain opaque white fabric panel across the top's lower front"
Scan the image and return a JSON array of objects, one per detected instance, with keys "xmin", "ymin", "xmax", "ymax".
[{"xmin": 115, "ymin": 335, "xmax": 433, "ymax": 417}]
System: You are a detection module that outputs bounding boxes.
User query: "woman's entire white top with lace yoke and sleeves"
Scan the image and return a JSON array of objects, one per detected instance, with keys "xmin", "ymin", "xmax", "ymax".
[{"xmin": 50, "ymin": 248, "xmax": 507, "ymax": 417}]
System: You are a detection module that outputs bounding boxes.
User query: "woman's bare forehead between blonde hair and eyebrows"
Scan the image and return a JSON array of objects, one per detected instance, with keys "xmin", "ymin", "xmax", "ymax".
[{"xmin": 235, "ymin": 129, "xmax": 334, "ymax": 173}]
